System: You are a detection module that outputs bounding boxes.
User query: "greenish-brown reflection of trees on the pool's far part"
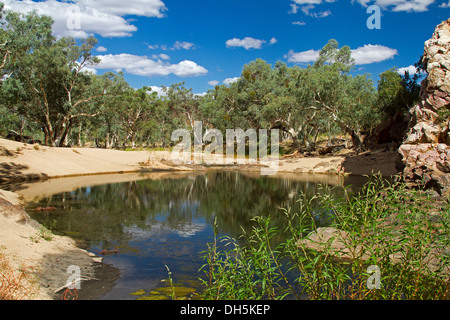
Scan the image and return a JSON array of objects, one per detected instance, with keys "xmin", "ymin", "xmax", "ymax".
[{"xmin": 31, "ymin": 172, "xmax": 348, "ymax": 246}]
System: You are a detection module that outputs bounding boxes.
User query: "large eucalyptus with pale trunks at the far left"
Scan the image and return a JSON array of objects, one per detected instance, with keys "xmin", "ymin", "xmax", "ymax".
[{"xmin": 2, "ymin": 7, "xmax": 125, "ymax": 147}]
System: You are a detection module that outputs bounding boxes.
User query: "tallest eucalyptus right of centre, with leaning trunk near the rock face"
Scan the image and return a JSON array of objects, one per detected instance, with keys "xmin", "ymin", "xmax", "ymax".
[{"xmin": 302, "ymin": 40, "xmax": 379, "ymax": 150}]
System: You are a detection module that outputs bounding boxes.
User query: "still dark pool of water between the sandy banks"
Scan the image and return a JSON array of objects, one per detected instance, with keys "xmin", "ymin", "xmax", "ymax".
[{"xmin": 29, "ymin": 171, "xmax": 364, "ymax": 299}]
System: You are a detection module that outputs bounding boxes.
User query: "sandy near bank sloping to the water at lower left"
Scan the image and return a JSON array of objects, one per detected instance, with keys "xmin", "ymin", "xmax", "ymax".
[{"xmin": 0, "ymin": 192, "xmax": 110, "ymax": 300}]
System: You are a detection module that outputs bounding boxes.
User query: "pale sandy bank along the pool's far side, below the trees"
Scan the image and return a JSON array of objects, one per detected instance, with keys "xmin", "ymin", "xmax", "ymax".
[{"xmin": 0, "ymin": 139, "xmax": 397, "ymax": 183}]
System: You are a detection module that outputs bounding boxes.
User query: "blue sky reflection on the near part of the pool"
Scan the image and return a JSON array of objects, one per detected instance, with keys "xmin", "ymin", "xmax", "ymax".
[{"xmin": 94, "ymin": 216, "xmax": 213, "ymax": 300}]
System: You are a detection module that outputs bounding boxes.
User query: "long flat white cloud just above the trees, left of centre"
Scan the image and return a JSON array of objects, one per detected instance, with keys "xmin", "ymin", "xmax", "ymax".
[{"xmin": 95, "ymin": 53, "xmax": 208, "ymax": 77}]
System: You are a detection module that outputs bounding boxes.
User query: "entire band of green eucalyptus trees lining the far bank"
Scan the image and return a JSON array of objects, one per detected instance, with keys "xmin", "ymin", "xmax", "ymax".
[{"xmin": 0, "ymin": 6, "xmax": 420, "ymax": 150}]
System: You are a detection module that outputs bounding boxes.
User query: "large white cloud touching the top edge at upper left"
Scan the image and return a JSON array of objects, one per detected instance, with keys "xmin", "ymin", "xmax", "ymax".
[{"xmin": 4, "ymin": 0, "xmax": 166, "ymax": 38}]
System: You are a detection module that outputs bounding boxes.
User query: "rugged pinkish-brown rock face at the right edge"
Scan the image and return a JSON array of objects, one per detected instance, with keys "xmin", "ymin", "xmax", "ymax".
[{"xmin": 399, "ymin": 19, "xmax": 450, "ymax": 193}]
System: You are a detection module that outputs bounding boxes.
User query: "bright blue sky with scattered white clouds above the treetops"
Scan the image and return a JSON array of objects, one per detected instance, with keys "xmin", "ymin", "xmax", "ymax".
[{"xmin": 3, "ymin": 0, "xmax": 450, "ymax": 94}]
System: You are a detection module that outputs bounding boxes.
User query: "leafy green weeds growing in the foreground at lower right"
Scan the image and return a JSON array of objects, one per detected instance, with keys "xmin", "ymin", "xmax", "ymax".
[{"xmin": 202, "ymin": 178, "xmax": 450, "ymax": 300}]
